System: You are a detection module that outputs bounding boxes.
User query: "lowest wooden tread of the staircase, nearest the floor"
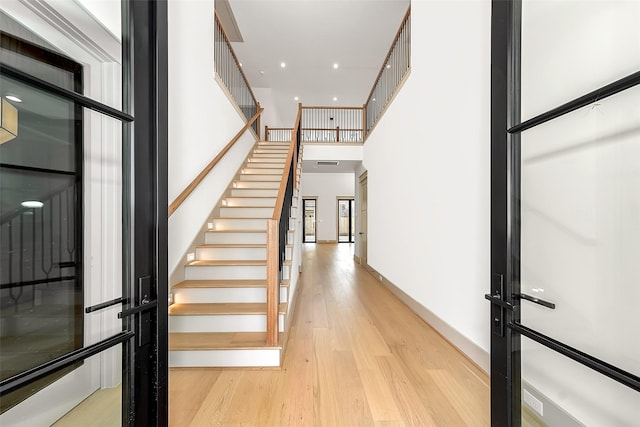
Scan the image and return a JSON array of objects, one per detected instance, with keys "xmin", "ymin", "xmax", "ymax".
[{"xmin": 169, "ymin": 332, "xmax": 284, "ymax": 350}]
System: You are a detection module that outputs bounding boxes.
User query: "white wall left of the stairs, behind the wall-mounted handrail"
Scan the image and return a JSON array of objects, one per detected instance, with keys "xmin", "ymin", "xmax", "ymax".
[{"xmin": 168, "ymin": 0, "xmax": 255, "ymax": 280}]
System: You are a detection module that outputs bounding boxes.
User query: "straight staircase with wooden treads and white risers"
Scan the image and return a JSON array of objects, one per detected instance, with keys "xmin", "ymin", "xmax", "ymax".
[{"xmin": 169, "ymin": 142, "xmax": 300, "ymax": 367}]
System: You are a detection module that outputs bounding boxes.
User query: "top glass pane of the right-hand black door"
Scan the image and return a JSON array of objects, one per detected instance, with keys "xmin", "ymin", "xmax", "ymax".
[{"xmin": 521, "ymin": 0, "xmax": 640, "ymax": 121}]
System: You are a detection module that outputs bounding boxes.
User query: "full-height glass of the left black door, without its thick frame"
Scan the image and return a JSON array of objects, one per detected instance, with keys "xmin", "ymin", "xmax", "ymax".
[{"xmin": 0, "ymin": 1, "xmax": 133, "ymax": 425}]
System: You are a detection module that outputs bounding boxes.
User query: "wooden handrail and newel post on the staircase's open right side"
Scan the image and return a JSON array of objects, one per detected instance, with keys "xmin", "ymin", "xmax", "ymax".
[{"xmin": 266, "ymin": 104, "xmax": 302, "ymax": 346}]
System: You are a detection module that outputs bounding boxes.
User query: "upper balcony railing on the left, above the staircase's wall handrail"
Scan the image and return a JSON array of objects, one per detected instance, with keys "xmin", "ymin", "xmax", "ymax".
[{"xmin": 214, "ymin": 14, "xmax": 260, "ymax": 135}]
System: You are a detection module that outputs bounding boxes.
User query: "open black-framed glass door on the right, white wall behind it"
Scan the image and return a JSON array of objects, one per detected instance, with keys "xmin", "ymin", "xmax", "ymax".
[{"xmin": 492, "ymin": 0, "xmax": 640, "ymax": 427}]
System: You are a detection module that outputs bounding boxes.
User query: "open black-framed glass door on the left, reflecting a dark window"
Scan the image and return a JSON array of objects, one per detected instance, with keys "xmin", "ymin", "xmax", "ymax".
[{"xmin": 0, "ymin": 0, "xmax": 167, "ymax": 425}]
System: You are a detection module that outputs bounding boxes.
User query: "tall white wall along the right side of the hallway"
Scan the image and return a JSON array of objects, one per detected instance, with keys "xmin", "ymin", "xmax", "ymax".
[{"xmin": 356, "ymin": 1, "xmax": 491, "ymax": 370}]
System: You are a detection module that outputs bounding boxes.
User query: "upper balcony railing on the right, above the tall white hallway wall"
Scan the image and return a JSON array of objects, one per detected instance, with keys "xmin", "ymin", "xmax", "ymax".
[{"xmin": 364, "ymin": 8, "xmax": 411, "ymax": 134}]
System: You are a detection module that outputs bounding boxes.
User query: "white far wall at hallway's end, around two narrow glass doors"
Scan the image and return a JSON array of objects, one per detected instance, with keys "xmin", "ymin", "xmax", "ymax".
[{"xmin": 301, "ymin": 173, "xmax": 355, "ymax": 242}]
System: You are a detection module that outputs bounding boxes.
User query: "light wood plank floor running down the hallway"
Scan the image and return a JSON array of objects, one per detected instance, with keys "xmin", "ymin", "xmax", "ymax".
[{"xmin": 169, "ymin": 243, "xmax": 490, "ymax": 427}]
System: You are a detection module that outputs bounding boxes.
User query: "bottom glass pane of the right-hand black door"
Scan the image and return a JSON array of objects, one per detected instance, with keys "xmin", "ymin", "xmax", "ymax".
[{"xmin": 521, "ymin": 337, "xmax": 640, "ymax": 427}]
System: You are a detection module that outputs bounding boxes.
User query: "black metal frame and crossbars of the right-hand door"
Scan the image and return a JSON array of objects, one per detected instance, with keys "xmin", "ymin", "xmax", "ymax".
[{"xmin": 485, "ymin": 0, "xmax": 640, "ymax": 426}]
